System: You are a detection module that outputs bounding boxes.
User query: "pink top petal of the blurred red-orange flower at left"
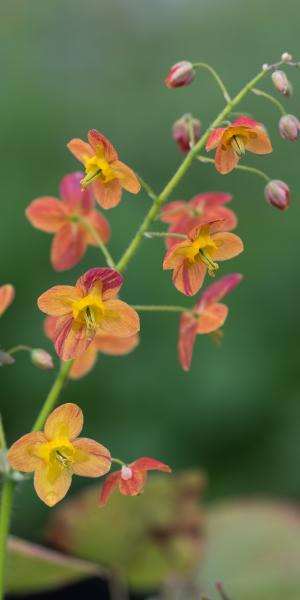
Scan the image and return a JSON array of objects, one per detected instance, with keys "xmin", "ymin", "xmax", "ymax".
[{"xmin": 59, "ymin": 171, "xmax": 94, "ymax": 215}]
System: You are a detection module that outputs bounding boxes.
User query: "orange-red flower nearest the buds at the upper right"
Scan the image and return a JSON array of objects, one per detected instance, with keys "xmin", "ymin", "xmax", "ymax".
[{"xmin": 205, "ymin": 117, "xmax": 272, "ymax": 175}]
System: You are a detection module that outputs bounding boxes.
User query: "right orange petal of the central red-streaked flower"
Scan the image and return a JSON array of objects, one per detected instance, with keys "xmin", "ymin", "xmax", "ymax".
[{"xmin": 100, "ymin": 300, "xmax": 140, "ymax": 337}]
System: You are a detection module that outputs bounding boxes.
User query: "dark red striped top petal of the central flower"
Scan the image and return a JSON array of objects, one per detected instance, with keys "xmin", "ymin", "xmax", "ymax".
[{"xmin": 76, "ymin": 267, "xmax": 123, "ymax": 300}]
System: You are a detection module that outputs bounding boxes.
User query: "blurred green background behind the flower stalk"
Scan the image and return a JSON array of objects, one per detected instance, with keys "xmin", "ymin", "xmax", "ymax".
[{"xmin": 0, "ymin": 0, "xmax": 300, "ymax": 539}]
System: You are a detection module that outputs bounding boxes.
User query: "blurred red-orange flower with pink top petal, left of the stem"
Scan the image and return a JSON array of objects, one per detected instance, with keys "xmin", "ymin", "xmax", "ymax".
[{"xmin": 26, "ymin": 172, "xmax": 110, "ymax": 271}]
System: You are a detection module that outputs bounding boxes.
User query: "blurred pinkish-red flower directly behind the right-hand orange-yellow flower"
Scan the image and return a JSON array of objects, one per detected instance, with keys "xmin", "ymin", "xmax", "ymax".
[{"xmin": 160, "ymin": 192, "xmax": 237, "ymax": 248}]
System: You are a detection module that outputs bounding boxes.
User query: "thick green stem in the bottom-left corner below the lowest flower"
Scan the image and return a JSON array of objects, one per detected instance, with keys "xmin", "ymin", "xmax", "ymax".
[{"xmin": 0, "ymin": 477, "xmax": 15, "ymax": 600}]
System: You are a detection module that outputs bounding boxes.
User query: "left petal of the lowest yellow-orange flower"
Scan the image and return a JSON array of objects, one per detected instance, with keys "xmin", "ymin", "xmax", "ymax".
[{"xmin": 7, "ymin": 431, "xmax": 47, "ymax": 473}]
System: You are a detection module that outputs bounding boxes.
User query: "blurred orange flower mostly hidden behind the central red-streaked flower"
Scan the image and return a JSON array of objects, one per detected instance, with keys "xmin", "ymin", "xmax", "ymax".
[{"xmin": 44, "ymin": 317, "xmax": 139, "ymax": 379}]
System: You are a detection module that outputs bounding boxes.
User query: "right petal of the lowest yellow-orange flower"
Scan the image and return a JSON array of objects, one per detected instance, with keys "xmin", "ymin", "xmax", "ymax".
[{"xmin": 73, "ymin": 438, "xmax": 111, "ymax": 477}]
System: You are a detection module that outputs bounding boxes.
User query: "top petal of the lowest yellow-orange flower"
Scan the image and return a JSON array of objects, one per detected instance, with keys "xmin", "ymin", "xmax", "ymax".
[{"xmin": 44, "ymin": 402, "xmax": 83, "ymax": 441}]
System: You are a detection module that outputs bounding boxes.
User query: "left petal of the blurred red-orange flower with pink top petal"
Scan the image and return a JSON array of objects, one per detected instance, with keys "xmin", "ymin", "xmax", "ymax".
[{"xmin": 25, "ymin": 196, "xmax": 66, "ymax": 233}]
